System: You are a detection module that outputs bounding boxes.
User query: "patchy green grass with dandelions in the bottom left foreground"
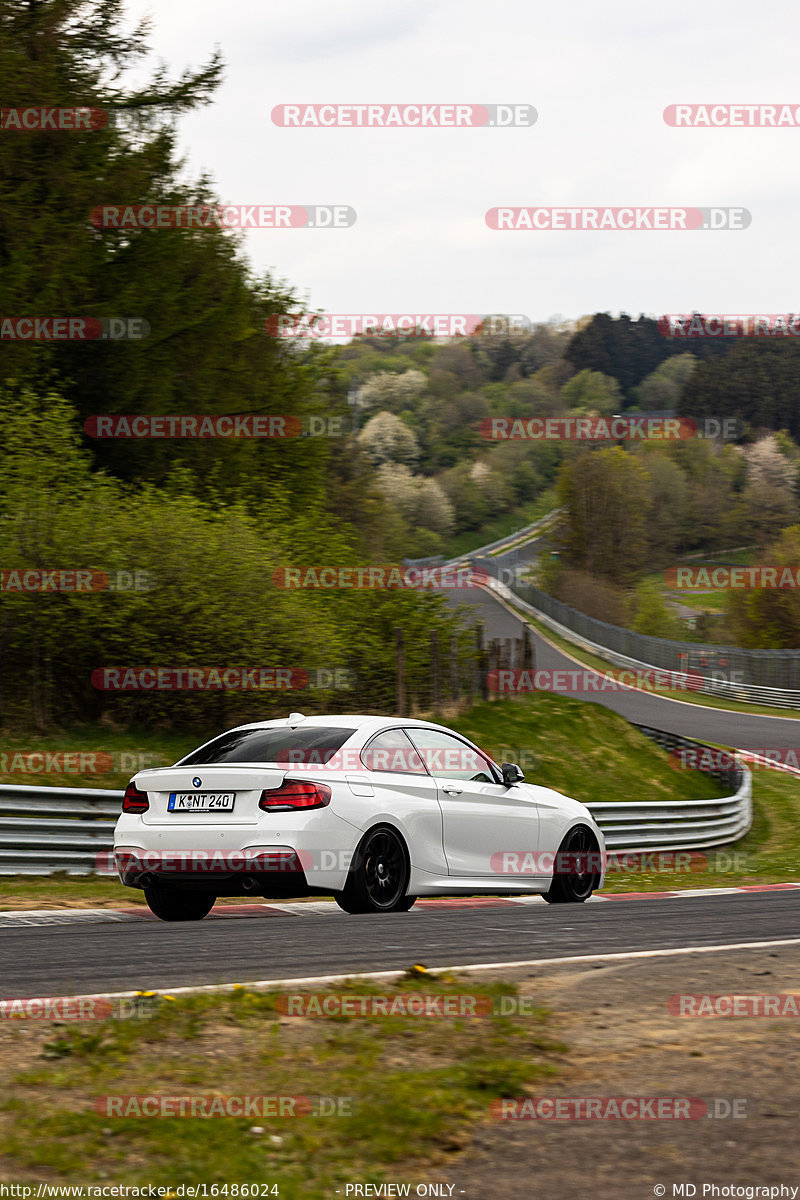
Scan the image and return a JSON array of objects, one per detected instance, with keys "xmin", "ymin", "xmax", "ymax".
[{"xmin": 0, "ymin": 974, "xmax": 565, "ymax": 1200}]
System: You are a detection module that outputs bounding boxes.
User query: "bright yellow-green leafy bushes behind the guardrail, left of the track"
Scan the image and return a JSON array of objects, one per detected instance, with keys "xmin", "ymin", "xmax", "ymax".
[{"xmin": 0, "ymin": 391, "xmax": 474, "ymax": 730}]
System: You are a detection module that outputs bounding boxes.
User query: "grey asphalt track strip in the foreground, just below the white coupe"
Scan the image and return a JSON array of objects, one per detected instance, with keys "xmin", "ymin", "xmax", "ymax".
[{"xmin": 0, "ymin": 890, "xmax": 800, "ymax": 998}]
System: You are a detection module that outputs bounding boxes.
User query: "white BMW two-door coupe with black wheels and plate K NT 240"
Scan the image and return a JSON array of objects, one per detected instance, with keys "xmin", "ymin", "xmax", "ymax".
[{"xmin": 114, "ymin": 713, "xmax": 606, "ymax": 920}]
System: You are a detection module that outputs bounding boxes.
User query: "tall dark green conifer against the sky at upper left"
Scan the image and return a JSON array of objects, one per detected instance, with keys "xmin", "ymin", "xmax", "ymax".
[{"xmin": 0, "ymin": 0, "xmax": 329, "ymax": 511}]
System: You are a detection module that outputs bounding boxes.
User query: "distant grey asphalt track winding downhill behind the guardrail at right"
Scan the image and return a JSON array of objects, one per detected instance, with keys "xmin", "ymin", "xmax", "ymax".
[{"xmin": 447, "ymin": 588, "xmax": 800, "ymax": 750}]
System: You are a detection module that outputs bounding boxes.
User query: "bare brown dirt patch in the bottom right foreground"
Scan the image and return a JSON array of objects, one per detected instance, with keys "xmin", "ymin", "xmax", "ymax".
[{"xmin": 438, "ymin": 947, "xmax": 800, "ymax": 1200}]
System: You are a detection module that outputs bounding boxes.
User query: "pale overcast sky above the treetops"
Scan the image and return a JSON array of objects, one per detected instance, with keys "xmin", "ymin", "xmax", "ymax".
[{"xmin": 122, "ymin": 0, "xmax": 800, "ymax": 320}]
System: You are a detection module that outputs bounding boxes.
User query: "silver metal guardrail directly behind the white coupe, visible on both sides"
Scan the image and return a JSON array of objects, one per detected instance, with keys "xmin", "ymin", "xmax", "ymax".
[{"xmin": 0, "ymin": 726, "xmax": 752, "ymax": 875}]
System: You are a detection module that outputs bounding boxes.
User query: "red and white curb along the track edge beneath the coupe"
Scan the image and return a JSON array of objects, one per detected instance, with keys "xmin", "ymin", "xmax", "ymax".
[{"xmin": 0, "ymin": 883, "xmax": 800, "ymax": 929}]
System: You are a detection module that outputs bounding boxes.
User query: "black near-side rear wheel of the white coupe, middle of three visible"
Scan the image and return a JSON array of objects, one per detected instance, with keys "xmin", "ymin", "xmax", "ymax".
[{"xmin": 336, "ymin": 826, "xmax": 416, "ymax": 913}]
